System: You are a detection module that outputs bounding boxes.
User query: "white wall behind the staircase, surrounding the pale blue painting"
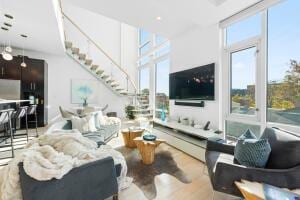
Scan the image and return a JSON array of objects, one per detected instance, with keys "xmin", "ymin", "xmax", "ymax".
[{"xmin": 10, "ymin": 7, "xmax": 138, "ymax": 123}]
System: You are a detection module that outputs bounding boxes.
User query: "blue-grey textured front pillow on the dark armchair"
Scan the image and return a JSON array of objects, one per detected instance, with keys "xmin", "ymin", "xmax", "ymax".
[{"xmin": 234, "ymin": 139, "xmax": 271, "ymax": 168}]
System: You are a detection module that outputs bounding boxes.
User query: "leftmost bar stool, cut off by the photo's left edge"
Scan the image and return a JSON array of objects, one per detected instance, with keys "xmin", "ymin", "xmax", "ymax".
[{"xmin": 0, "ymin": 109, "xmax": 15, "ymax": 157}]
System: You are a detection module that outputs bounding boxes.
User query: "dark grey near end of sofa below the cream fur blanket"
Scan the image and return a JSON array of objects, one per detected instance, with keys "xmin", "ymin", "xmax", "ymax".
[{"xmin": 19, "ymin": 157, "xmax": 121, "ymax": 200}]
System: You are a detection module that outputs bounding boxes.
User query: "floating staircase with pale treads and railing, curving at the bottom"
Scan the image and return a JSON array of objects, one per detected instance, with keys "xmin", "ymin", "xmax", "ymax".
[{"xmin": 62, "ymin": 11, "xmax": 153, "ymax": 120}]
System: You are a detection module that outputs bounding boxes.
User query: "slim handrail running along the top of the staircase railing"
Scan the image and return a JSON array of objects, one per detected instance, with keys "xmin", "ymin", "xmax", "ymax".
[{"xmin": 61, "ymin": 9, "xmax": 137, "ymax": 93}]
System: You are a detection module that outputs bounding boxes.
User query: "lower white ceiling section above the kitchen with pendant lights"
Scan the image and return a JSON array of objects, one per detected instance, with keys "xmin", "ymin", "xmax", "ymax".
[{"xmin": 0, "ymin": 0, "xmax": 64, "ymax": 54}]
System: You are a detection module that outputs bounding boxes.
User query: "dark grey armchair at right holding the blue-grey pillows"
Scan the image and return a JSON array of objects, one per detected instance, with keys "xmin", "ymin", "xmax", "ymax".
[{"xmin": 205, "ymin": 128, "xmax": 300, "ymax": 197}]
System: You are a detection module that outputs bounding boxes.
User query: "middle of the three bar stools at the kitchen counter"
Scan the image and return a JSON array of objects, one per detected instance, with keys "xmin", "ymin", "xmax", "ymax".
[{"xmin": 11, "ymin": 106, "xmax": 28, "ymax": 142}]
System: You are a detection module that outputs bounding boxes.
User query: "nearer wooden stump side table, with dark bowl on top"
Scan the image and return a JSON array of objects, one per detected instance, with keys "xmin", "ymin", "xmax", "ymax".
[{"xmin": 134, "ymin": 137, "xmax": 166, "ymax": 165}]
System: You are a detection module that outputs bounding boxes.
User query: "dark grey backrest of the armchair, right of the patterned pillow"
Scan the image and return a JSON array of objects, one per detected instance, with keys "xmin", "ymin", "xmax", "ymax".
[{"xmin": 261, "ymin": 128, "xmax": 300, "ymax": 169}]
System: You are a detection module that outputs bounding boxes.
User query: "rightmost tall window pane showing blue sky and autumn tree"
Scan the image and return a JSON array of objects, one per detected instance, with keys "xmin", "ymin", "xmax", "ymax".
[{"xmin": 267, "ymin": 0, "xmax": 300, "ymax": 126}]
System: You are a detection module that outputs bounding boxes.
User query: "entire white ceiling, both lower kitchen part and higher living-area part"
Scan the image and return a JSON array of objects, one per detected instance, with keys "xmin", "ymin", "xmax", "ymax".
[{"xmin": 0, "ymin": 0, "xmax": 260, "ymax": 54}]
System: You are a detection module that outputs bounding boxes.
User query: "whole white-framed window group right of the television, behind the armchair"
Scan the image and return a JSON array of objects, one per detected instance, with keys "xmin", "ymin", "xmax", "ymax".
[{"xmin": 221, "ymin": 0, "xmax": 300, "ymax": 138}]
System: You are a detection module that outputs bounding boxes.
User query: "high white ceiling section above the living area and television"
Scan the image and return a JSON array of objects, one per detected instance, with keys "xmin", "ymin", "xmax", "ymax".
[{"xmin": 64, "ymin": 0, "xmax": 260, "ymax": 38}]
